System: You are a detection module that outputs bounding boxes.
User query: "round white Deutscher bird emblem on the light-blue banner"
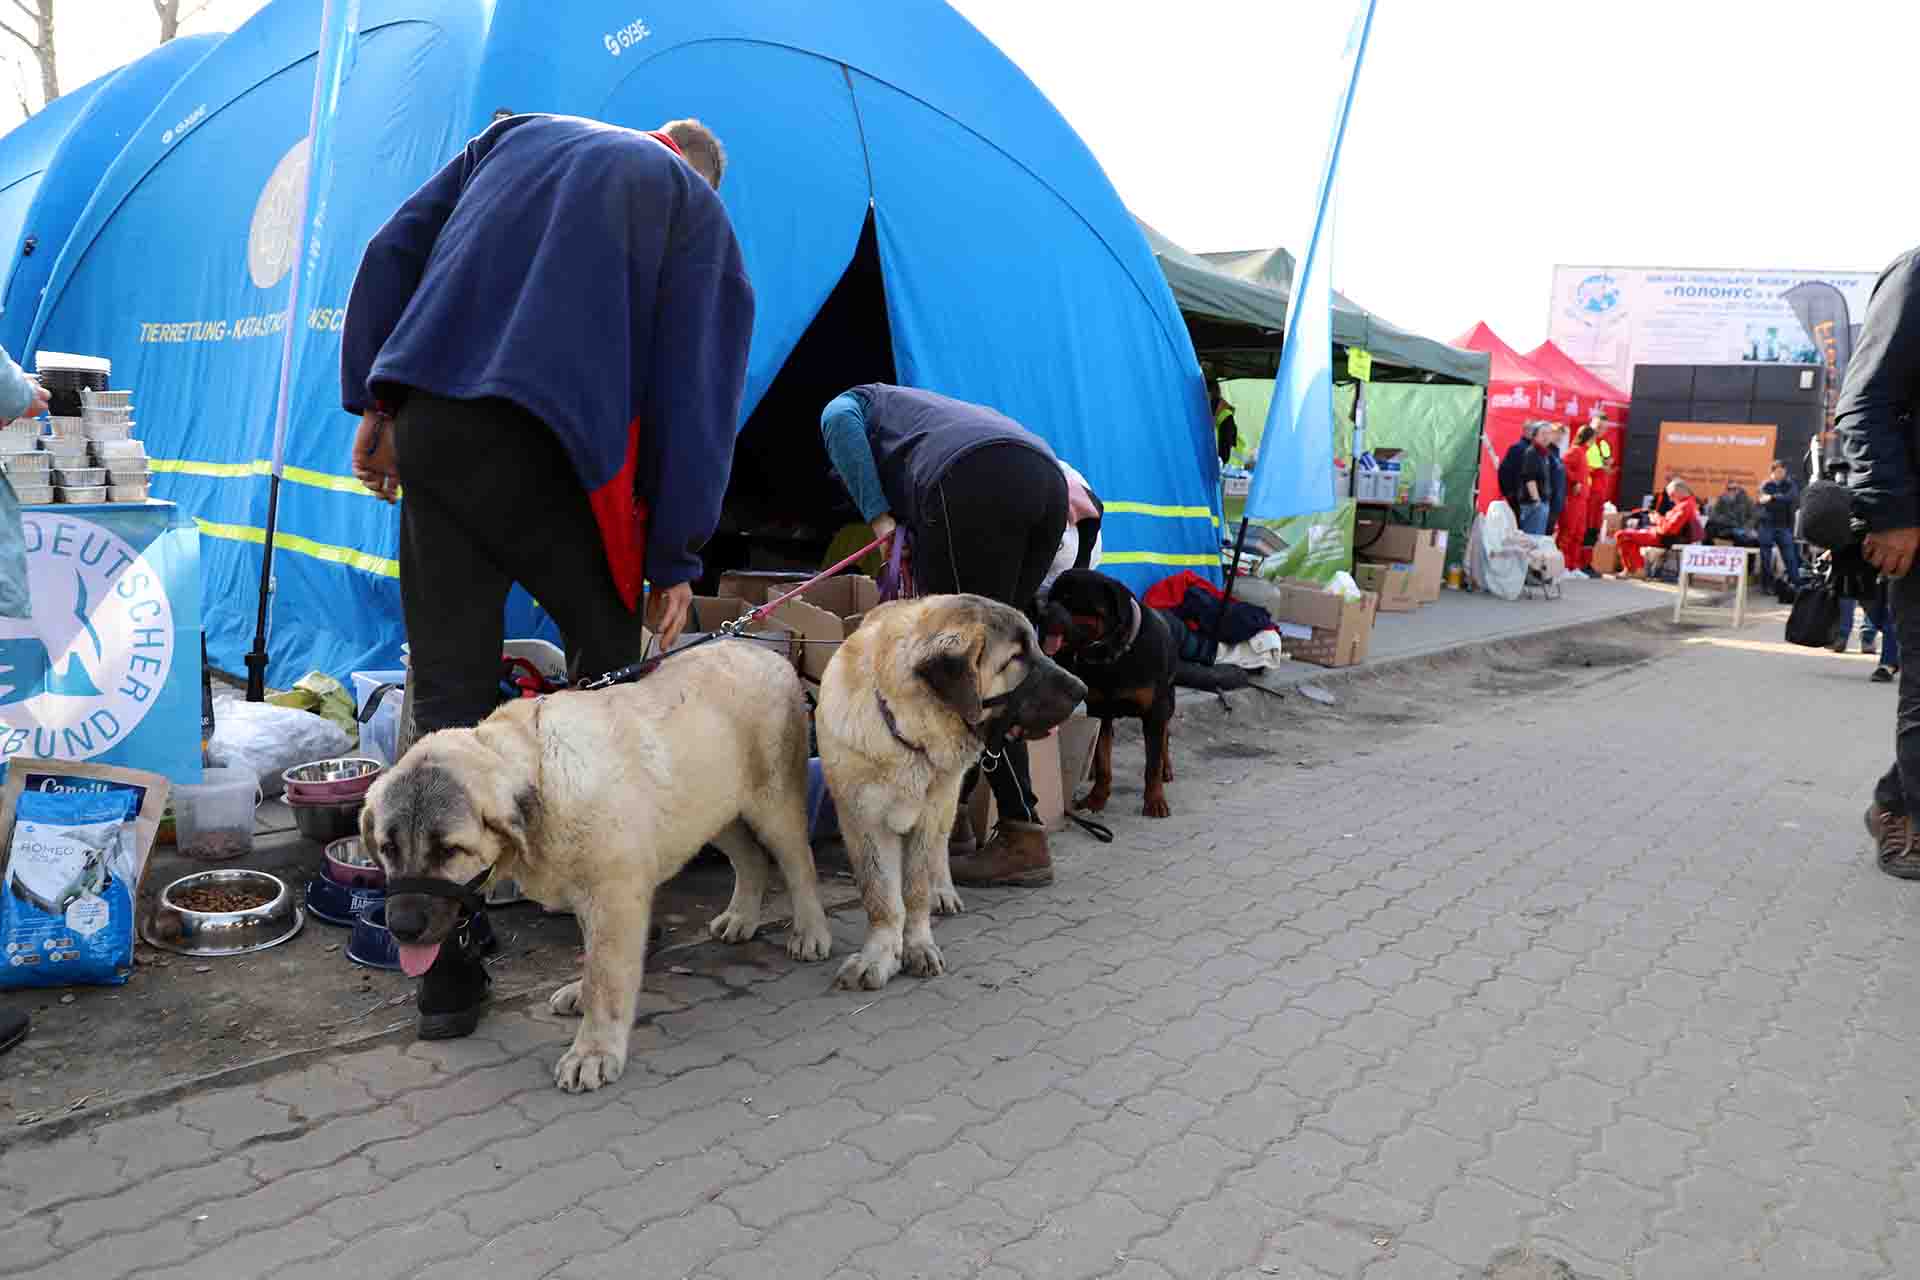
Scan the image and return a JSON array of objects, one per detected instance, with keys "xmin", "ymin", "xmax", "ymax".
[{"xmin": 0, "ymin": 510, "xmax": 173, "ymax": 760}]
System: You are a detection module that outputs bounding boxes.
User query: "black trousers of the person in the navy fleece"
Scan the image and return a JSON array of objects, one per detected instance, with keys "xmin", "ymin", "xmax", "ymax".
[{"xmin": 394, "ymin": 391, "xmax": 641, "ymax": 735}]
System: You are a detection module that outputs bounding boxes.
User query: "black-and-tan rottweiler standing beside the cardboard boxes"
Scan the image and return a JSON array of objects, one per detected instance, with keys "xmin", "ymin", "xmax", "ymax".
[{"xmin": 1039, "ymin": 568, "xmax": 1179, "ymax": 818}]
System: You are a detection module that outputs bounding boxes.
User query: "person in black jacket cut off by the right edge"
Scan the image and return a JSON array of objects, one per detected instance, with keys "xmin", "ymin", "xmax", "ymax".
[{"xmin": 1834, "ymin": 249, "xmax": 1920, "ymax": 881}]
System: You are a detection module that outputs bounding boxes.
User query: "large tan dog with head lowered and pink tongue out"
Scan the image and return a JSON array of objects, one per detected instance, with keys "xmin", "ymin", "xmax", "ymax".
[{"xmin": 361, "ymin": 641, "xmax": 831, "ymax": 1092}]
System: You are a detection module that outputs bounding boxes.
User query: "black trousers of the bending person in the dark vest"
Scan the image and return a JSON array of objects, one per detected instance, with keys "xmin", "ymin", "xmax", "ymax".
[{"xmin": 914, "ymin": 445, "xmax": 1068, "ymax": 821}]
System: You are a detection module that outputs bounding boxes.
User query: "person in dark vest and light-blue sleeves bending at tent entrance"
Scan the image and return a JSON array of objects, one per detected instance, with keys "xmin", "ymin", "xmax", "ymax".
[{"xmin": 820, "ymin": 382, "xmax": 1085, "ymax": 885}]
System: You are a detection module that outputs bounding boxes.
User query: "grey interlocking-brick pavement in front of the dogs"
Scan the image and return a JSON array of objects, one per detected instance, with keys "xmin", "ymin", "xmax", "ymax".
[{"xmin": 0, "ymin": 624, "xmax": 1920, "ymax": 1280}]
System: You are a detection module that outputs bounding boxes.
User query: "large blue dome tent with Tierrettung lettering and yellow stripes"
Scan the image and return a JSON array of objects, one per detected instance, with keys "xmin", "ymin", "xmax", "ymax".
[{"xmin": 18, "ymin": 0, "xmax": 1217, "ymax": 681}]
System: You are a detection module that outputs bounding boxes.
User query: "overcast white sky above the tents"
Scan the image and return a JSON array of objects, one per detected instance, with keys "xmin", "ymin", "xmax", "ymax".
[{"xmin": 18, "ymin": 0, "xmax": 1920, "ymax": 349}]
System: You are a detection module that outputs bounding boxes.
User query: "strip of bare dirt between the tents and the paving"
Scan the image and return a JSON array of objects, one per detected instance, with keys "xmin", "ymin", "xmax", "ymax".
[{"xmin": 0, "ymin": 616, "xmax": 1681, "ymax": 1148}]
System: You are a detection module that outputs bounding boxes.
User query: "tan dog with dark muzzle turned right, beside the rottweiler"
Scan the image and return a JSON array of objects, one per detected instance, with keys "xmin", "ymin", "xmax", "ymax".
[{"xmin": 814, "ymin": 595, "xmax": 1087, "ymax": 990}]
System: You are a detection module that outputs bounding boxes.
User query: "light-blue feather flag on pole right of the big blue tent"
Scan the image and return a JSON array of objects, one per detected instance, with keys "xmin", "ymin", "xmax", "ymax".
[{"xmin": 1246, "ymin": 0, "xmax": 1375, "ymax": 520}]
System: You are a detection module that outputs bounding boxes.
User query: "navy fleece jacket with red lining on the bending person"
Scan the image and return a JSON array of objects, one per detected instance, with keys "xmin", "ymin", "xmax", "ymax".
[{"xmin": 340, "ymin": 115, "xmax": 753, "ymax": 604}]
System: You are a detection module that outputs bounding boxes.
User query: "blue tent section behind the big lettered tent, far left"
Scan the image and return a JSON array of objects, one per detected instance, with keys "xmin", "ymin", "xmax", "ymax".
[{"xmin": 0, "ymin": 35, "xmax": 225, "ymax": 351}]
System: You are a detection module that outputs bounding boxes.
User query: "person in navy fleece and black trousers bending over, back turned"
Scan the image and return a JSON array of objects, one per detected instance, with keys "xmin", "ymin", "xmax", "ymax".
[{"xmin": 340, "ymin": 115, "xmax": 753, "ymax": 1038}]
